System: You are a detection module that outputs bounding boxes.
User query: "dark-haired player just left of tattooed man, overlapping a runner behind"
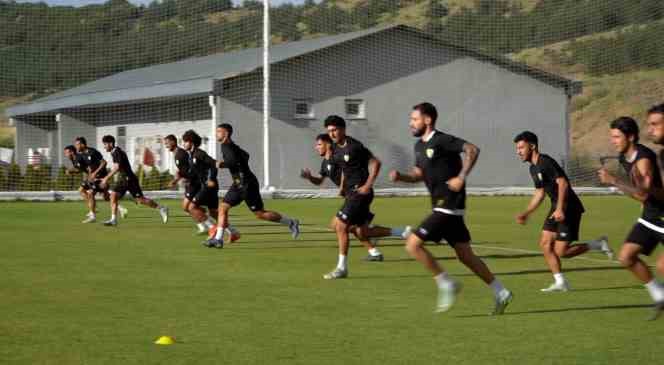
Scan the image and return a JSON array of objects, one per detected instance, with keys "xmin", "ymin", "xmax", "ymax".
[{"xmin": 323, "ymin": 115, "xmax": 381, "ymax": 280}]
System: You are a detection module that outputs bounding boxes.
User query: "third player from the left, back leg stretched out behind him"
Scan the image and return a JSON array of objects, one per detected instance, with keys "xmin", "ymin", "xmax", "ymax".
[{"xmin": 100, "ymin": 135, "xmax": 168, "ymax": 226}]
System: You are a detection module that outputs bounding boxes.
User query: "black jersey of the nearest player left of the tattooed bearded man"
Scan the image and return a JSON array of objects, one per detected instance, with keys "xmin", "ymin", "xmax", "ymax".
[{"xmin": 332, "ymin": 137, "xmax": 373, "ymax": 191}]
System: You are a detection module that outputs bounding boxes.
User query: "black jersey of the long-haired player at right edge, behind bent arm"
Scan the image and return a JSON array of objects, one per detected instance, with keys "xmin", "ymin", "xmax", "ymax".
[{"xmin": 618, "ymin": 144, "xmax": 664, "ymax": 226}]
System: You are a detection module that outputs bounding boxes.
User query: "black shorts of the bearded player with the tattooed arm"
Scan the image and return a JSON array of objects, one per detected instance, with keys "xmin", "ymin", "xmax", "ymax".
[{"xmin": 413, "ymin": 211, "xmax": 470, "ymax": 247}]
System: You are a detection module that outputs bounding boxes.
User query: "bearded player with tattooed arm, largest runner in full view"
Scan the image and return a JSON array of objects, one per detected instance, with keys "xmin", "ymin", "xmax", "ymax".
[{"xmin": 390, "ymin": 102, "xmax": 513, "ymax": 315}]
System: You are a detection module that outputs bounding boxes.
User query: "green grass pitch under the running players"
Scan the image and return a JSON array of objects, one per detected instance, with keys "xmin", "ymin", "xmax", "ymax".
[{"xmin": 0, "ymin": 197, "xmax": 664, "ymax": 365}]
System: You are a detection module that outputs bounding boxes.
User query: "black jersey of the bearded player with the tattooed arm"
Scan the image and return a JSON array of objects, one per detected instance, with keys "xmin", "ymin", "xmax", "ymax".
[{"xmin": 415, "ymin": 131, "xmax": 466, "ymax": 210}]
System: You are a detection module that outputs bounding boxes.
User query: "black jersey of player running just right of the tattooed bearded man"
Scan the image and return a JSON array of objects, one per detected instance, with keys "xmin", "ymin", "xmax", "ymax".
[{"xmin": 530, "ymin": 154, "xmax": 585, "ymax": 213}]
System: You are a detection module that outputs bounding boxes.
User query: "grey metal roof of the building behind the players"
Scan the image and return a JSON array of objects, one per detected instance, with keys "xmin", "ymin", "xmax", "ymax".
[{"xmin": 6, "ymin": 25, "xmax": 574, "ymax": 117}]
